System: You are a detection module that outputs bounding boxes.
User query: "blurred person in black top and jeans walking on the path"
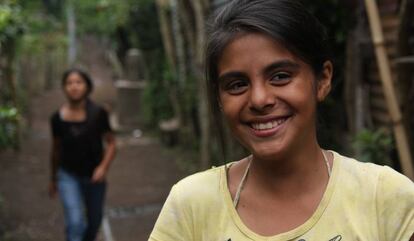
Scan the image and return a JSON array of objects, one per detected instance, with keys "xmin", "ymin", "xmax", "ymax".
[{"xmin": 49, "ymin": 69, "xmax": 115, "ymax": 241}]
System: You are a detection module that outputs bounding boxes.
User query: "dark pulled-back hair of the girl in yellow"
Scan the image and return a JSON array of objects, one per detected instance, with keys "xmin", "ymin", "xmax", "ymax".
[{"xmin": 205, "ymin": 0, "xmax": 330, "ymax": 159}]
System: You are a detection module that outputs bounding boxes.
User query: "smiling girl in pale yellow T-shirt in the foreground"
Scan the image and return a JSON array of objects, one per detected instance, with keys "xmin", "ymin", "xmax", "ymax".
[{"xmin": 150, "ymin": 0, "xmax": 414, "ymax": 241}]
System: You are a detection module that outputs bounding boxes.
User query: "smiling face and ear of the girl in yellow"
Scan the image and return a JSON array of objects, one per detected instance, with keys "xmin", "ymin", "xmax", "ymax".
[{"xmin": 218, "ymin": 33, "xmax": 332, "ymax": 160}]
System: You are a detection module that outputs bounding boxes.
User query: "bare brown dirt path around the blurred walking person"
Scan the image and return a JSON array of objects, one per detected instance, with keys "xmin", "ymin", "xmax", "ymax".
[{"xmin": 0, "ymin": 36, "xmax": 190, "ymax": 241}]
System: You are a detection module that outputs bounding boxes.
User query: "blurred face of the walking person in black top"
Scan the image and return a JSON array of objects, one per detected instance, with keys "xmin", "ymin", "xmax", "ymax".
[{"xmin": 63, "ymin": 72, "xmax": 88, "ymax": 102}]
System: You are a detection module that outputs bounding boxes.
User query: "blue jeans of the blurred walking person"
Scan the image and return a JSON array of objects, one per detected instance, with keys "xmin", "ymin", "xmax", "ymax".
[{"xmin": 57, "ymin": 169, "xmax": 106, "ymax": 241}]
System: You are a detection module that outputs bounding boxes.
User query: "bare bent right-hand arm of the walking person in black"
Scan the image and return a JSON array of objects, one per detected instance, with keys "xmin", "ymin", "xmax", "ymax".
[{"xmin": 92, "ymin": 132, "xmax": 116, "ymax": 182}]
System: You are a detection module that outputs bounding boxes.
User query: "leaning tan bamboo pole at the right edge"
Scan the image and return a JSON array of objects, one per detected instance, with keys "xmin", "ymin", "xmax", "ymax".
[{"xmin": 365, "ymin": 0, "xmax": 414, "ymax": 180}]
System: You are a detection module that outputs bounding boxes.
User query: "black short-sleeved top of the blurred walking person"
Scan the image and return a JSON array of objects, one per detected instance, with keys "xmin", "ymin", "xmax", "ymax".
[{"xmin": 50, "ymin": 100, "xmax": 112, "ymax": 177}]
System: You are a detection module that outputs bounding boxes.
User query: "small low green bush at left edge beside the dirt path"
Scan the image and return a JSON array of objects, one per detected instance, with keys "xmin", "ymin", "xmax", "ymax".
[{"xmin": 0, "ymin": 106, "xmax": 19, "ymax": 150}]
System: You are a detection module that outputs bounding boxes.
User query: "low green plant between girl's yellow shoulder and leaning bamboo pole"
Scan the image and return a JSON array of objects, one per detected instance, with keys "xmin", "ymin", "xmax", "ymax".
[{"xmin": 353, "ymin": 129, "xmax": 393, "ymax": 166}]
